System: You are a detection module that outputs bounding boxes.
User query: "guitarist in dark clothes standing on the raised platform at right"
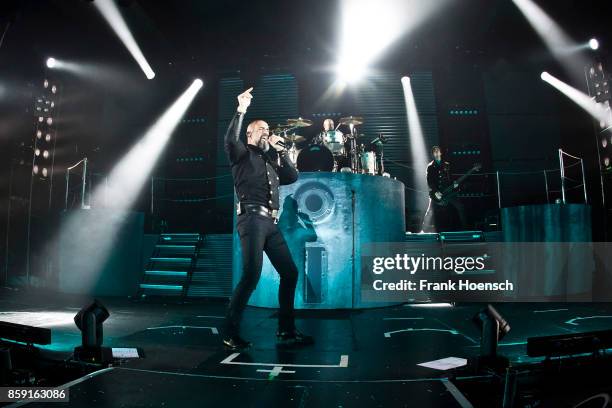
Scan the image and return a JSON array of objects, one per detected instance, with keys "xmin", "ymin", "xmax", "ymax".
[{"xmin": 423, "ymin": 146, "xmax": 466, "ymax": 232}]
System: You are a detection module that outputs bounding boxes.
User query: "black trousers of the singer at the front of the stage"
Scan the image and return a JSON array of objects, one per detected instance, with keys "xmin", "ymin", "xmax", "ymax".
[{"xmin": 225, "ymin": 214, "xmax": 298, "ymax": 336}]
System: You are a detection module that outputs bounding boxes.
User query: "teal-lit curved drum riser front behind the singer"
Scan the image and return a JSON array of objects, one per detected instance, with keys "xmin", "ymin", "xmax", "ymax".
[{"xmin": 233, "ymin": 172, "xmax": 406, "ymax": 309}]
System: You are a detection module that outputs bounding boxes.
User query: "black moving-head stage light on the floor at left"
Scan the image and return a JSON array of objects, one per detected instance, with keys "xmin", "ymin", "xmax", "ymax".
[{"xmin": 74, "ymin": 299, "xmax": 112, "ymax": 363}]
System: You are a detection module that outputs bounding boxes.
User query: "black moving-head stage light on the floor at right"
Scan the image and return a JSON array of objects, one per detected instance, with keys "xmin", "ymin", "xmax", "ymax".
[{"xmin": 472, "ymin": 305, "xmax": 510, "ymax": 366}]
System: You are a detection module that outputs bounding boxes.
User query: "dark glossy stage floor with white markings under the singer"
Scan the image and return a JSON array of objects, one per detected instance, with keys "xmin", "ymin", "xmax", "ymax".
[{"xmin": 0, "ymin": 291, "xmax": 612, "ymax": 407}]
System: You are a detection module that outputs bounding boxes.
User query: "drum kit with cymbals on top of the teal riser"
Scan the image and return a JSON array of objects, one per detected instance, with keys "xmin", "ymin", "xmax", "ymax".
[{"xmin": 272, "ymin": 116, "xmax": 388, "ymax": 176}]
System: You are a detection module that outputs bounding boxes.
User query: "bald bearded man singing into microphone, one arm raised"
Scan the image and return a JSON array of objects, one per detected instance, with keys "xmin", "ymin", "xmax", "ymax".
[{"xmin": 223, "ymin": 88, "xmax": 314, "ymax": 350}]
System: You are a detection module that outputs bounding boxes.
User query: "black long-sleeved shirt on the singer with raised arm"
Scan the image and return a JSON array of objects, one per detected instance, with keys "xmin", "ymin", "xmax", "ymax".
[{"xmin": 225, "ymin": 112, "xmax": 298, "ymax": 210}]
